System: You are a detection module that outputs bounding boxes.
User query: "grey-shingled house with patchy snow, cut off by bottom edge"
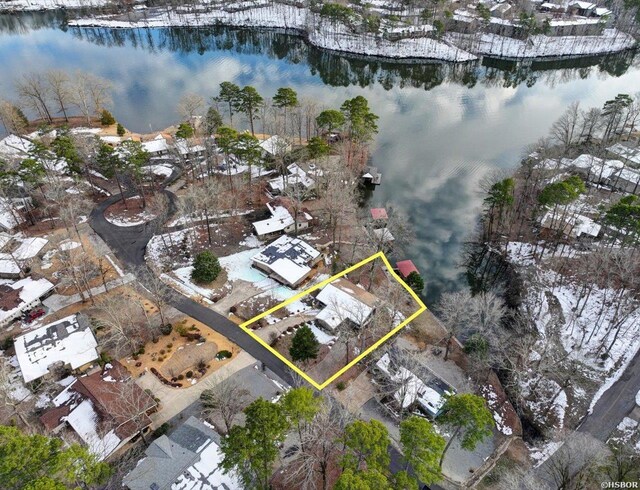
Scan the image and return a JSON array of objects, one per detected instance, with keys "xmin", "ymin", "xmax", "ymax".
[{"xmin": 122, "ymin": 417, "xmax": 242, "ymax": 490}]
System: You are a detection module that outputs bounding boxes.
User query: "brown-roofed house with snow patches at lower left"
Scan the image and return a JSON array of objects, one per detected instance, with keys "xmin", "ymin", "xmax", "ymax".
[{"xmin": 40, "ymin": 361, "xmax": 157, "ymax": 460}]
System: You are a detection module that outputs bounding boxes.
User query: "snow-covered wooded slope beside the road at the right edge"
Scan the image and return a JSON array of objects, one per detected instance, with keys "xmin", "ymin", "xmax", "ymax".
[{"xmin": 508, "ymin": 238, "xmax": 640, "ymax": 440}]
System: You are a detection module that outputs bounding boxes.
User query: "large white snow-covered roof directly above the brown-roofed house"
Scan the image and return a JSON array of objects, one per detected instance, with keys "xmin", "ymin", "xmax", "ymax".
[{"xmin": 15, "ymin": 315, "xmax": 98, "ymax": 382}]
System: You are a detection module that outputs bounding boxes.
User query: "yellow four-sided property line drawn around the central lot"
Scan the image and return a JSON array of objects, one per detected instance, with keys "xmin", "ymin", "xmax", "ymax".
[{"xmin": 240, "ymin": 252, "xmax": 427, "ymax": 390}]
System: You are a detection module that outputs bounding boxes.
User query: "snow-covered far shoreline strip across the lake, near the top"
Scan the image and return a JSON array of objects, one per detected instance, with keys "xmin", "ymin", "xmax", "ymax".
[{"xmin": 0, "ymin": 0, "xmax": 637, "ymax": 63}]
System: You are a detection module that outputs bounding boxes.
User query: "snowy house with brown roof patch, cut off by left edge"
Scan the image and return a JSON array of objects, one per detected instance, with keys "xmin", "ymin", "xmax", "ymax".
[{"xmin": 0, "ymin": 277, "xmax": 54, "ymax": 327}]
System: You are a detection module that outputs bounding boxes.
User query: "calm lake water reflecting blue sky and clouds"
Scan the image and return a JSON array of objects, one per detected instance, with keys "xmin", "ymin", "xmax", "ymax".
[{"xmin": 0, "ymin": 14, "xmax": 640, "ymax": 305}]
